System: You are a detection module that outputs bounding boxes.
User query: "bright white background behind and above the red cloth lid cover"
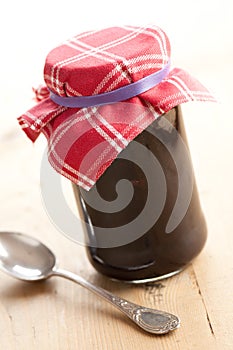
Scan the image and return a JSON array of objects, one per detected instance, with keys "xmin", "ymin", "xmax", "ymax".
[{"xmin": 0, "ymin": 0, "xmax": 233, "ymax": 121}]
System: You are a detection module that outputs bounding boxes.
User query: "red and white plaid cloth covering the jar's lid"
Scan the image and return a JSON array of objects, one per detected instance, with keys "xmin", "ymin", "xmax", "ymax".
[{"xmin": 18, "ymin": 26, "xmax": 215, "ymax": 190}]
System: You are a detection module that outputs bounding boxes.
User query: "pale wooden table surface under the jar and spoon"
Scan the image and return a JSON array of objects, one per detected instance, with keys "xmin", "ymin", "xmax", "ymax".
[{"xmin": 0, "ymin": 13, "xmax": 233, "ymax": 350}]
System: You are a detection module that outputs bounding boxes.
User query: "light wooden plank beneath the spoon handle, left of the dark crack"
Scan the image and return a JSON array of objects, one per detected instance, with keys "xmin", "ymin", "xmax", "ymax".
[{"xmin": 0, "ymin": 266, "xmax": 219, "ymax": 350}]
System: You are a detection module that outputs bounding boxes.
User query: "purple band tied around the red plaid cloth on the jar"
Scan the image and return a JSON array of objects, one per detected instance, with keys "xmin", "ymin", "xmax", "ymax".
[{"xmin": 50, "ymin": 61, "xmax": 170, "ymax": 108}]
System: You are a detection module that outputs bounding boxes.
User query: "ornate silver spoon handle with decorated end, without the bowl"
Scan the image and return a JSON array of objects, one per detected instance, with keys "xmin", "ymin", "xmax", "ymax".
[{"xmin": 53, "ymin": 269, "xmax": 180, "ymax": 334}]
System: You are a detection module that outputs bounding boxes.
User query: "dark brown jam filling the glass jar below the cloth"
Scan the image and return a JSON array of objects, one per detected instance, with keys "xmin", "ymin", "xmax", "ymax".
[{"xmin": 73, "ymin": 106, "xmax": 207, "ymax": 281}]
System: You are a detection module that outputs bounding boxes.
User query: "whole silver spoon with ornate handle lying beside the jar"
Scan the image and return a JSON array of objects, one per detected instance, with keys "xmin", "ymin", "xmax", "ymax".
[{"xmin": 0, "ymin": 232, "xmax": 180, "ymax": 334}]
